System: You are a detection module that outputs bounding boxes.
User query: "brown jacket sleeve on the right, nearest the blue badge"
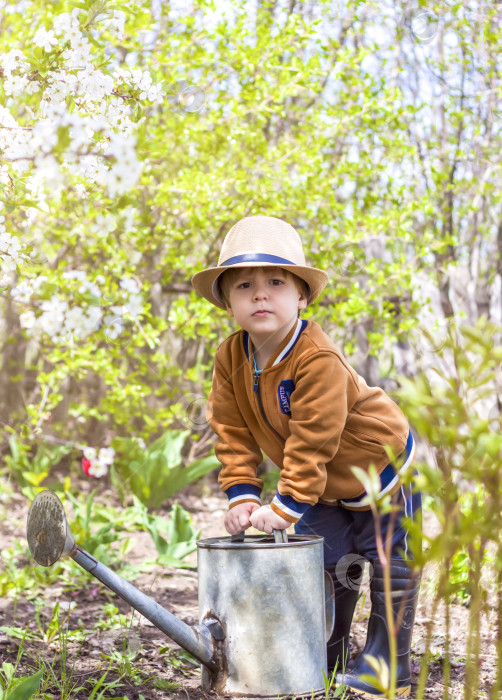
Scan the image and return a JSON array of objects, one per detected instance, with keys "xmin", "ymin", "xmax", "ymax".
[{"xmin": 271, "ymin": 352, "xmax": 359, "ymax": 523}]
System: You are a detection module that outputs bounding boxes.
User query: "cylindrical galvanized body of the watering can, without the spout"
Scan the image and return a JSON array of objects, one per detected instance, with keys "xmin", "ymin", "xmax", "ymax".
[{"xmin": 197, "ymin": 536, "xmax": 332, "ymax": 698}]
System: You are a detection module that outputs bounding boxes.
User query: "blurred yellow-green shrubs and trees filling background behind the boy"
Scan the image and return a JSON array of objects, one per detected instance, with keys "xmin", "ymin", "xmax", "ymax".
[{"xmin": 0, "ymin": 0, "xmax": 502, "ymax": 457}]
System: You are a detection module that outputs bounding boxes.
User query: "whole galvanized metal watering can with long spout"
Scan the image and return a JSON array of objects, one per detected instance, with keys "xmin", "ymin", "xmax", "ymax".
[{"xmin": 27, "ymin": 491, "xmax": 334, "ymax": 698}]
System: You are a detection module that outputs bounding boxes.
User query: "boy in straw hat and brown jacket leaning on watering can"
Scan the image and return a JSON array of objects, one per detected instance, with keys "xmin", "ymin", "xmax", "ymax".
[{"xmin": 192, "ymin": 216, "xmax": 420, "ymax": 697}]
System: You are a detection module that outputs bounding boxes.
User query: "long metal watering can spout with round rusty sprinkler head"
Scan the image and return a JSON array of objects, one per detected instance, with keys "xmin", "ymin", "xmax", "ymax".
[{"xmin": 27, "ymin": 491, "xmax": 224, "ymax": 671}]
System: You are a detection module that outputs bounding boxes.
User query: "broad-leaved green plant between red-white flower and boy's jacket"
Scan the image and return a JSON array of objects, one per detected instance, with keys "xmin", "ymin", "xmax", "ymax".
[{"xmin": 111, "ymin": 430, "xmax": 219, "ymax": 508}]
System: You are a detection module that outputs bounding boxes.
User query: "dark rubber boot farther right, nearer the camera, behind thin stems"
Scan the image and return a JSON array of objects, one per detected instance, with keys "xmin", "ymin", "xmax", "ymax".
[{"xmin": 336, "ymin": 559, "xmax": 420, "ymax": 697}]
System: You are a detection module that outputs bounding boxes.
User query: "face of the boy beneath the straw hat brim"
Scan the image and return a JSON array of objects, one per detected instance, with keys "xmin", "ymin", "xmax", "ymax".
[{"xmin": 227, "ymin": 267, "xmax": 307, "ymax": 347}]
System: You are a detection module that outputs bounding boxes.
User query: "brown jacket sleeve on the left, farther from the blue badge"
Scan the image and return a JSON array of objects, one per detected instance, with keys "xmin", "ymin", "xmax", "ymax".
[{"xmin": 207, "ymin": 353, "xmax": 263, "ymax": 508}]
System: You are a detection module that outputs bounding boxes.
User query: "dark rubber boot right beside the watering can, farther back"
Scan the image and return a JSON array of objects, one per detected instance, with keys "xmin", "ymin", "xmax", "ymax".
[{"xmin": 328, "ymin": 557, "xmax": 365, "ymax": 676}]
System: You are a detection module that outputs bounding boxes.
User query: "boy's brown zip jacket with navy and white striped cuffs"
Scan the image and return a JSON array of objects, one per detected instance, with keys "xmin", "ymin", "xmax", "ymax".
[{"xmin": 208, "ymin": 320, "xmax": 409, "ymax": 522}]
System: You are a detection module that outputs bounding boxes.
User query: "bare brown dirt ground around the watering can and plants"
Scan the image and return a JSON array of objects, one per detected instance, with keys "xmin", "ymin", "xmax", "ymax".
[{"xmin": 0, "ymin": 480, "xmax": 496, "ymax": 700}]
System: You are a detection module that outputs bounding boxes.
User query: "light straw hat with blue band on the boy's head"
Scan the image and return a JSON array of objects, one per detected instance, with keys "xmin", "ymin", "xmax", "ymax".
[{"xmin": 192, "ymin": 216, "xmax": 328, "ymax": 309}]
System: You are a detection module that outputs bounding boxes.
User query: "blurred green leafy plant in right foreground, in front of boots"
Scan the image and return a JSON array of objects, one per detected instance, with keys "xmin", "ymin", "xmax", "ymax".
[{"xmin": 396, "ymin": 318, "xmax": 502, "ymax": 698}]
